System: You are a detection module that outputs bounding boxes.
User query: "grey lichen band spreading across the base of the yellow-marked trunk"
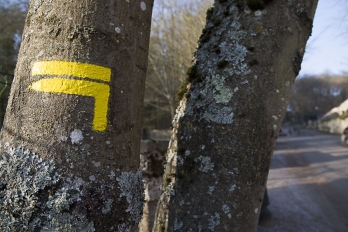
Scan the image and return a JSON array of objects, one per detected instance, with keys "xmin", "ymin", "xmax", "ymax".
[{"xmin": 0, "ymin": 147, "xmax": 144, "ymax": 232}]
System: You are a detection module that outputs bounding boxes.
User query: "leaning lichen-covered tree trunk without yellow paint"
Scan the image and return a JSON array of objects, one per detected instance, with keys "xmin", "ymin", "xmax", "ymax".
[{"xmin": 154, "ymin": 0, "xmax": 317, "ymax": 231}]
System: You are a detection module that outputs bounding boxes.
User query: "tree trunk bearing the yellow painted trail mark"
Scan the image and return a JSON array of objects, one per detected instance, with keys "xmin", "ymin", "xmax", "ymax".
[{"xmin": 0, "ymin": 0, "xmax": 153, "ymax": 231}]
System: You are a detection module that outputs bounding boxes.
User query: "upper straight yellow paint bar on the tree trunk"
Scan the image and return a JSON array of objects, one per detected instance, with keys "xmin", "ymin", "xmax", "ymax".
[{"xmin": 31, "ymin": 61, "xmax": 111, "ymax": 82}]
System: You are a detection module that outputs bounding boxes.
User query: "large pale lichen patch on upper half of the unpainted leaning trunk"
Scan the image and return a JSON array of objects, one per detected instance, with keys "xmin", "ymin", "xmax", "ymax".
[{"xmin": 186, "ymin": 5, "xmax": 251, "ymax": 124}]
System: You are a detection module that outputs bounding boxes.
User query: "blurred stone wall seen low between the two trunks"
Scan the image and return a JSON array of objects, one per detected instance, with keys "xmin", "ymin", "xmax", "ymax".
[{"xmin": 139, "ymin": 138, "xmax": 169, "ymax": 232}]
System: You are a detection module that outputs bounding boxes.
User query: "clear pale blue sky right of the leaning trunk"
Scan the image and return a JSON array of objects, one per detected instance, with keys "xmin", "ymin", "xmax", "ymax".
[{"xmin": 299, "ymin": 0, "xmax": 348, "ymax": 76}]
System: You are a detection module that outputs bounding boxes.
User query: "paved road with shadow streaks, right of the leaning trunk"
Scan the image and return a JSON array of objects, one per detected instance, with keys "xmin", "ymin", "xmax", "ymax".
[{"xmin": 258, "ymin": 129, "xmax": 348, "ymax": 232}]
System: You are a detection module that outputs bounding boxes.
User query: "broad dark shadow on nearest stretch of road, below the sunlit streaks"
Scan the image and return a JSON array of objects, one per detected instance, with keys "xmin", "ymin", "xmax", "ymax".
[{"xmin": 258, "ymin": 179, "xmax": 348, "ymax": 232}]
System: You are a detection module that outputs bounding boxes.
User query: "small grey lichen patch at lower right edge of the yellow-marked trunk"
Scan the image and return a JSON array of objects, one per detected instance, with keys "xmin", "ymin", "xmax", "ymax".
[{"xmin": 116, "ymin": 168, "xmax": 145, "ymax": 227}]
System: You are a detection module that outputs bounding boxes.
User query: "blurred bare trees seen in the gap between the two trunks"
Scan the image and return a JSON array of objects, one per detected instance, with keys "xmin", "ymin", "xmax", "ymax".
[{"xmin": 144, "ymin": 0, "xmax": 212, "ymax": 129}]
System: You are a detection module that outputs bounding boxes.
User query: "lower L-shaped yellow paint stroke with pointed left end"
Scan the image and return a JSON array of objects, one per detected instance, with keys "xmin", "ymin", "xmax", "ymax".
[{"xmin": 29, "ymin": 78, "xmax": 110, "ymax": 131}]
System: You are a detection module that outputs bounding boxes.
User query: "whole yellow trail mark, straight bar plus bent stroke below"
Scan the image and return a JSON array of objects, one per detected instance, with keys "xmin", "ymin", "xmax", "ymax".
[{"xmin": 29, "ymin": 61, "xmax": 111, "ymax": 131}]
